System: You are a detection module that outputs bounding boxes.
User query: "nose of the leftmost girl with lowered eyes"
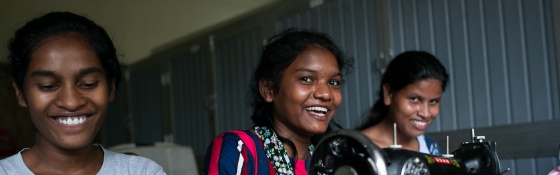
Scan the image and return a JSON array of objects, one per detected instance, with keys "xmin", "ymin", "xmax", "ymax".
[{"xmin": 54, "ymin": 85, "xmax": 86, "ymax": 111}]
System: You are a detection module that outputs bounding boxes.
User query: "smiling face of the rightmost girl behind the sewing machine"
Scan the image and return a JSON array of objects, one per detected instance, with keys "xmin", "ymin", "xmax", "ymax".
[{"xmin": 383, "ymin": 79, "xmax": 443, "ymax": 137}]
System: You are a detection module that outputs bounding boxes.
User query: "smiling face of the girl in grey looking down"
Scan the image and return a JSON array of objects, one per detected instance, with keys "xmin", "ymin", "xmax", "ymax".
[{"xmin": 14, "ymin": 33, "xmax": 114, "ymax": 149}]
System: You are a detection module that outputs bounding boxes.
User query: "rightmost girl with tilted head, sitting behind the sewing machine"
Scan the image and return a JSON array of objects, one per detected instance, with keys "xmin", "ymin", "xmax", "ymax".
[{"xmin": 358, "ymin": 51, "xmax": 449, "ymax": 155}]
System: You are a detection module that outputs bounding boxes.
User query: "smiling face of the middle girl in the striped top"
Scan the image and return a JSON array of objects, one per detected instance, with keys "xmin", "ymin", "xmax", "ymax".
[{"xmin": 261, "ymin": 45, "xmax": 342, "ymax": 137}]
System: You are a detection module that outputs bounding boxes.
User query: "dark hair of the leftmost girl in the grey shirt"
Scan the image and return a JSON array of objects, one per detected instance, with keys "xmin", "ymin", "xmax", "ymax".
[{"xmin": 8, "ymin": 12, "xmax": 121, "ymax": 94}]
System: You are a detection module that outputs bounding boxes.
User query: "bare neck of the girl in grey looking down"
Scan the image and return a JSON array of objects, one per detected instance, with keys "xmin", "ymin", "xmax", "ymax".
[{"xmin": 22, "ymin": 139, "xmax": 103, "ymax": 174}]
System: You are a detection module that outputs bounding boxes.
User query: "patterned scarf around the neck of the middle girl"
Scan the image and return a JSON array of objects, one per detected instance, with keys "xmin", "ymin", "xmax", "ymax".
[{"xmin": 255, "ymin": 126, "xmax": 315, "ymax": 175}]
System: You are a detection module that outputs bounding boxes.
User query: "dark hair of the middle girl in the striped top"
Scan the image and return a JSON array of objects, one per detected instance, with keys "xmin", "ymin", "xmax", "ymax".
[{"xmin": 249, "ymin": 28, "xmax": 353, "ymax": 126}]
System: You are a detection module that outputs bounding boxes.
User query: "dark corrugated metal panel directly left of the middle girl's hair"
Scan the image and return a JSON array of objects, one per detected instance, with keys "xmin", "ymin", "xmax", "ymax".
[{"xmin": 216, "ymin": 29, "xmax": 262, "ymax": 133}]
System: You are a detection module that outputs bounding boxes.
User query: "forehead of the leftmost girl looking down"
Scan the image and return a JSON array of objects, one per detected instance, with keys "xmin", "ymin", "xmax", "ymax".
[{"xmin": 27, "ymin": 34, "xmax": 103, "ymax": 73}]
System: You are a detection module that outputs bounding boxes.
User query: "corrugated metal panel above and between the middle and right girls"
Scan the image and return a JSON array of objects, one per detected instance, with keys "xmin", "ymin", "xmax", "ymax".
[{"xmin": 276, "ymin": 0, "xmax": 379, "ymax": 128}]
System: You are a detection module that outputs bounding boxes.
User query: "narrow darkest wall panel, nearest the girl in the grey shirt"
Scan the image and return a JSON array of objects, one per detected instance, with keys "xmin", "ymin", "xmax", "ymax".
[{"xmin": 129, "ymin": 66, "xmax": 163, "ymax": 144}]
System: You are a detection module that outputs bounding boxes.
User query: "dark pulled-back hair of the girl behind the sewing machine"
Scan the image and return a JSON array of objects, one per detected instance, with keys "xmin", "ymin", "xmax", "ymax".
[{"xmin": 358, "ymin": 51, "xmax": 449, "ymax": 130}]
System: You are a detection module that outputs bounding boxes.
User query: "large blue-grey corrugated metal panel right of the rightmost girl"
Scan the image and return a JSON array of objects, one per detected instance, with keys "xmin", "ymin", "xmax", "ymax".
[{"xmin": 390, "ymin": 0, "xmax": 558, "ymax": 131}]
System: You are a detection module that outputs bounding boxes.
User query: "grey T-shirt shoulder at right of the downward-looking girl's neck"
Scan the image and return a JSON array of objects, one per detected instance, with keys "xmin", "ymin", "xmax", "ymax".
[{"xmin": 99, "ymin": 148, "xmax": 166, "ymax": 174}]
